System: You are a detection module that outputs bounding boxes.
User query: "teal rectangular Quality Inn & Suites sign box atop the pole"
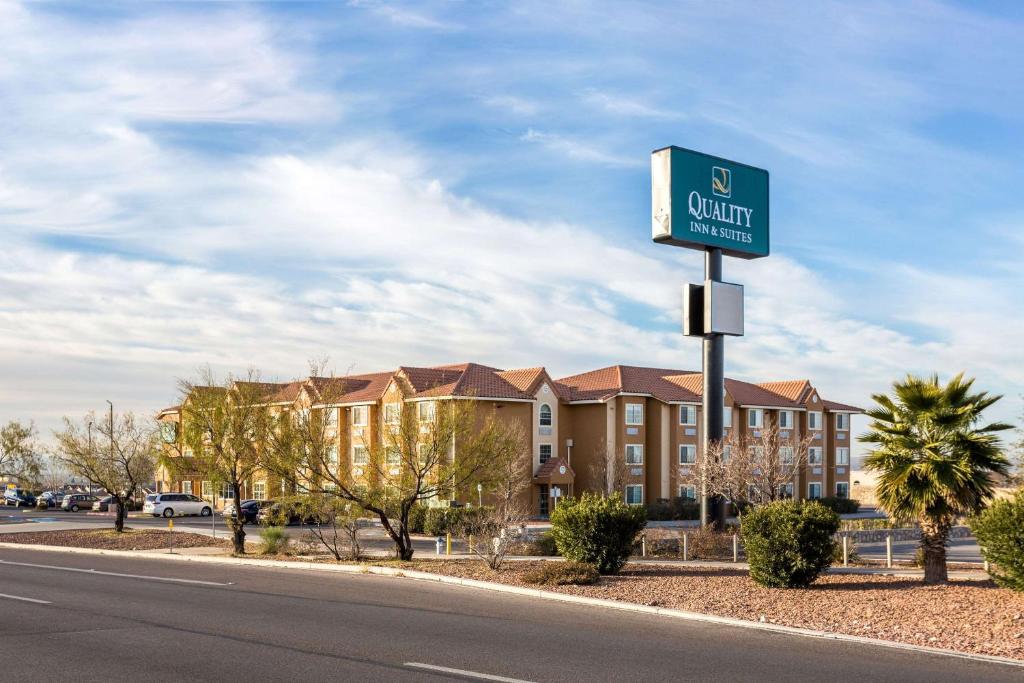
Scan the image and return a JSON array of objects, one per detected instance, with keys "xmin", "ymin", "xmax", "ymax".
[{"xmin": 650, "ymin": 146, "xmax": 768, "ymax": 258}]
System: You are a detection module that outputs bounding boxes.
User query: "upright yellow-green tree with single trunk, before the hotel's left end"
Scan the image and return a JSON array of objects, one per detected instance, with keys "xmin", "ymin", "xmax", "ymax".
[{"xmin": 163, "ymin": 369, "xmax": 276, "ymax": 555}]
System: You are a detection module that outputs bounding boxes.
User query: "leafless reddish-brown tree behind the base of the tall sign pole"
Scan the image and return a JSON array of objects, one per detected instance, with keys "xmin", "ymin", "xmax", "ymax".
[{"xmin": 679, "ymin": 425, "xmax": 812, "ymax": 516}]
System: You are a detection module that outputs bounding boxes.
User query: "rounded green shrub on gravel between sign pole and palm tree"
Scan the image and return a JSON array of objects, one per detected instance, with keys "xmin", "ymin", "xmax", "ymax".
[{"xmin": 740, "ymin": 501, "xmax": 839, "ymax": 588}]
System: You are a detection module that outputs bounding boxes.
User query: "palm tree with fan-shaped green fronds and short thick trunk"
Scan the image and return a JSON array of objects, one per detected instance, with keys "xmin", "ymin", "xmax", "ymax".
[{"xmin": 860, "ymin": 373, "xmax": 1013, "ymax": 584}]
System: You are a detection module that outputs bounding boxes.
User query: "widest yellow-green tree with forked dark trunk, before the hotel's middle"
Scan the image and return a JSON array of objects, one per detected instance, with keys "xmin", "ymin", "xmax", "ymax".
[{"xmin": 266, "ymin": 378, "xmax": 528, "ymax": 560}]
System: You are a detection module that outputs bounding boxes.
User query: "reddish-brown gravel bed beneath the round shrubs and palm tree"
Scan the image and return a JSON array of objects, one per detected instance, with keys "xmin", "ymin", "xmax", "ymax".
[{"xmin": 405, "ymin": 560, "xmax": 1024, "ymax": 659}]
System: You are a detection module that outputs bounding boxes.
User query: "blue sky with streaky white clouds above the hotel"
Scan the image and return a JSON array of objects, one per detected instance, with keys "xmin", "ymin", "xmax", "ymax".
[{"xmin": 0, "ymin": 0, "xmax": 1024, "ymax": 456}]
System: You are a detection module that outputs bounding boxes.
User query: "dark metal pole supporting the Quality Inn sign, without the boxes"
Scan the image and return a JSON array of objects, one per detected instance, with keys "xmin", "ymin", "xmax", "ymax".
[{"xmin": 700, "ymin": 249, "xmax": 725, "ymax": 525}]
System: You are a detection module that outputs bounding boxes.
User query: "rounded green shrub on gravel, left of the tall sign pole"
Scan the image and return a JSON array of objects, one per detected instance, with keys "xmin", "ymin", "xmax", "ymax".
[{"xmin": 551, "ymin": 493, "xmax": 647, "ymax": 573}]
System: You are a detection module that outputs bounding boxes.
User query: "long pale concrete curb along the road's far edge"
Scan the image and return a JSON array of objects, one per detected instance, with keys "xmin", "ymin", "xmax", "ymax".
[{"xmin": 0, "ymin": 543, "xmax": 1024, "ymax": 669}]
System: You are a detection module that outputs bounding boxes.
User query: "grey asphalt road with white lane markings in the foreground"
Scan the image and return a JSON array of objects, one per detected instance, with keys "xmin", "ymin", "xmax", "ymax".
[{"xmin": 0, "ymin": 549, "xmax": 1024, "ymax": 683}]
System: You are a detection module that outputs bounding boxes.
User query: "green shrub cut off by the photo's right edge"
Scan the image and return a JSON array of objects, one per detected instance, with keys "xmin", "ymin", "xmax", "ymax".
[{"xmin": 969, "ymin": 489, "xmax": 1024, "ymax": 591}]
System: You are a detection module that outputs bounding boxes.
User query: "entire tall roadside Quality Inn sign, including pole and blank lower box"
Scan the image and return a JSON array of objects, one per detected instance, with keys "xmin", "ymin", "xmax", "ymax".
[{"xmin": 651, "ymin": 146, "xmax": 769, "ymax": 524}]
